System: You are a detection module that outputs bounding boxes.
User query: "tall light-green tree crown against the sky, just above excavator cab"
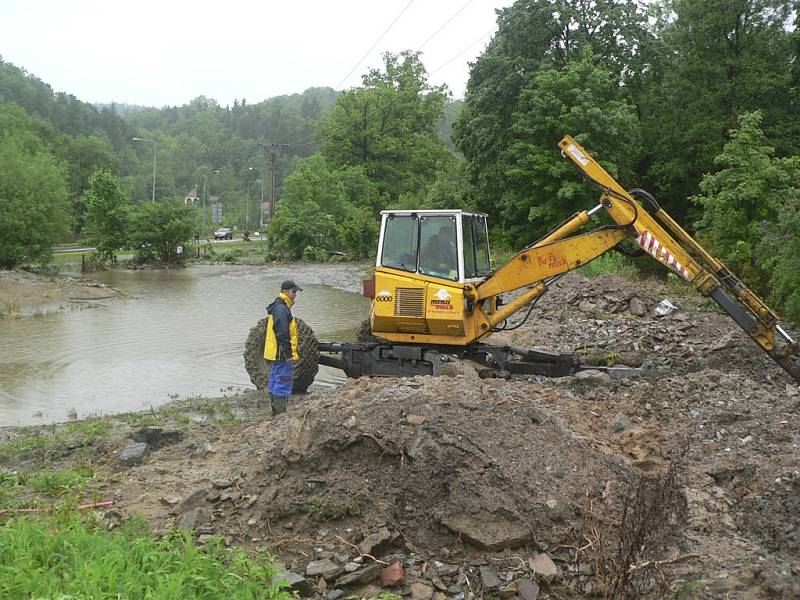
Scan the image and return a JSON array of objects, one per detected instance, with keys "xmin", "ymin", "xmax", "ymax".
[{"xmin": 322, "ymin": 52, "xmax": 455, "ymax": 202}]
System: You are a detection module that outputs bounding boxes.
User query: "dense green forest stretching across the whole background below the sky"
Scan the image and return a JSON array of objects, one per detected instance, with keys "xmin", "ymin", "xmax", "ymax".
[{"xmin": 0, "ymin": 0, "xmax": 800, "ymax": 319}]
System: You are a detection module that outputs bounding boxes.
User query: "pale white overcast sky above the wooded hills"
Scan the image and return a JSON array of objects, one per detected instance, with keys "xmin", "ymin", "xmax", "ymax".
[{"xmin": 0, "ymin": 0, "xmax": 513, "ymax": 107}]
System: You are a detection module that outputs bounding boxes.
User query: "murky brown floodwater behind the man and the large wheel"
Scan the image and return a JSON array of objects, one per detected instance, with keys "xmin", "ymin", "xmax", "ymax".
[{"xmin": 0, "ymin": 266, "xmax": 369, "ymax": 425}]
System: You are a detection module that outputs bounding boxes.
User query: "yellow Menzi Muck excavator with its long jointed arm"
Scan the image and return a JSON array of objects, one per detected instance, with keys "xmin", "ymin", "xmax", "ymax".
[{"xmin": 248, "ymin": 136, "xmax": 800, "ymax": 389}]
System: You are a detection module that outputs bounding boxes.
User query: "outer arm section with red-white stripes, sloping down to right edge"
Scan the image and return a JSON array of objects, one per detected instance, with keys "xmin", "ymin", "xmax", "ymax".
[{"xmin": 556, "ymin": 136, "xmax": 800, "ymax": 382}]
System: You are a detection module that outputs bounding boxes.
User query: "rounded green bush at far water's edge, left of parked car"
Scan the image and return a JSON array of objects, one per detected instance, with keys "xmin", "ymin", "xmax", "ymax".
[{"xmin": 130, "ymin": 200, "xmax": 197, "ymax": 263}]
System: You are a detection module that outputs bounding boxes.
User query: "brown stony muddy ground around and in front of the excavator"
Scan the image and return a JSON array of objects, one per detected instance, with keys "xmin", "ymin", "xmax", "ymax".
[{"xmin": 0, "ymin": 274, "xmax": 800, "ymax": 600}]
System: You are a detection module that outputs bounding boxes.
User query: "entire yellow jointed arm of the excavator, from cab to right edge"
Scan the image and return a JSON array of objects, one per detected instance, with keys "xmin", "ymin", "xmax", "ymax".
[{"xmin": 477, "ymin": 136, "xmax": 800, "ymax": 382}]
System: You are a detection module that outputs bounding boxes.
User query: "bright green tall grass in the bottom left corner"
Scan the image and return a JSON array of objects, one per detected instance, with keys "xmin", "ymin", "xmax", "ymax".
[{"xmin": 0, "ymin": 511, "xmax": 293, "ymax": 600}]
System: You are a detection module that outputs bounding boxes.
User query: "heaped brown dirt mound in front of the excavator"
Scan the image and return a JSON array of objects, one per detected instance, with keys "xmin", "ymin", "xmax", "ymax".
[{"xmin": 223, "ymin": 374, "xmax": 627, "ymax": 553}]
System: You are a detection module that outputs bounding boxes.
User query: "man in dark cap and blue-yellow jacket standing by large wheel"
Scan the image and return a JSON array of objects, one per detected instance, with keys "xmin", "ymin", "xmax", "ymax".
[{"xmin": 264, "ymin": 279, "xmax": 303, "ymax": 416}]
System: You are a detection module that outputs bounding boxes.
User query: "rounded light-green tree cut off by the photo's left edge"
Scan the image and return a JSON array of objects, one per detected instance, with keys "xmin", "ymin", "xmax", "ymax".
[{"xmin": 0, "ymin": 104, "xmax": 67, "ymax": 269}]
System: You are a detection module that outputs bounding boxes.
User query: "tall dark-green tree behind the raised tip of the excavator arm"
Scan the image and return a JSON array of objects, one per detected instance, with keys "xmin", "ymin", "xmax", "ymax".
[{"xmin": 454, "ymin": 0, "xmax": 651, "ymax": 246}]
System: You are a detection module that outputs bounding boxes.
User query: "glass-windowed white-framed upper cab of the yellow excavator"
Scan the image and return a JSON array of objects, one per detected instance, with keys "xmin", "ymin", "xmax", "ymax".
[{"xmin": 375, "ymin": 210, "xmax": 490, "ymax": 284}]
